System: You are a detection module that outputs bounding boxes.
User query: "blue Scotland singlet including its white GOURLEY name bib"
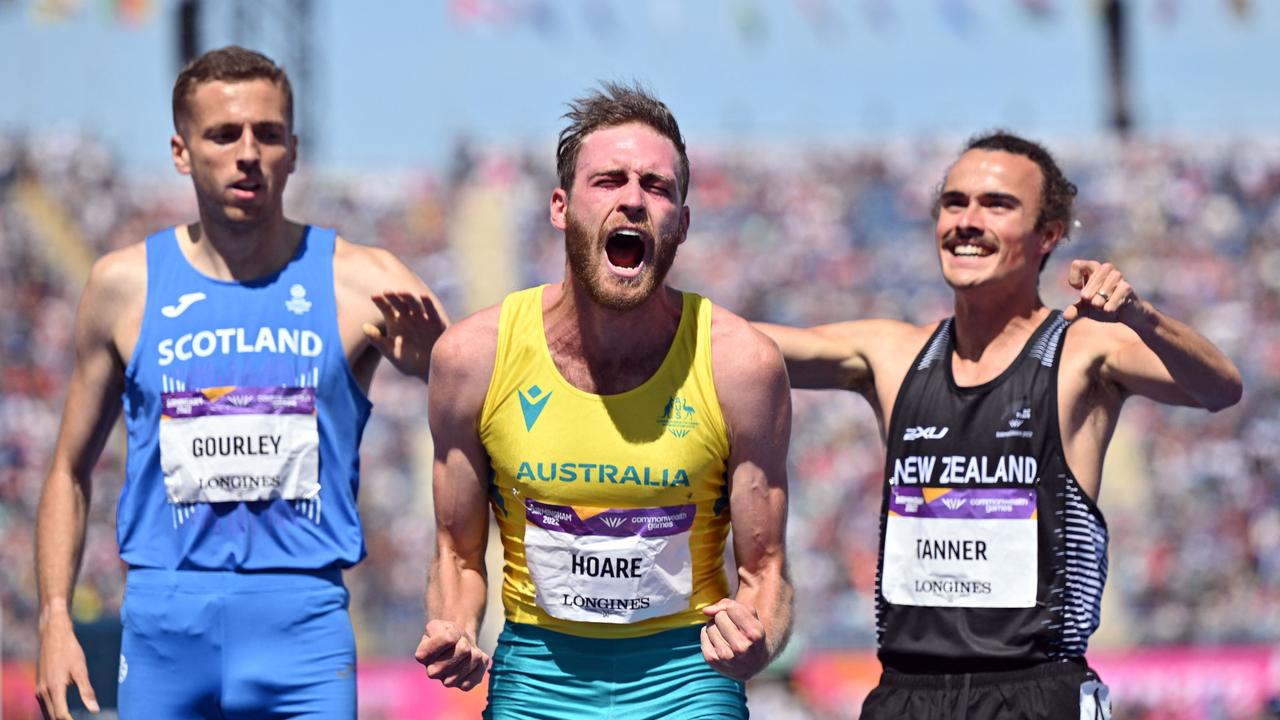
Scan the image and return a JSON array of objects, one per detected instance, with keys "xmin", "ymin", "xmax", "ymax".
[{"xmin": 116, "ymin": 227, "xmax": 370, "ymax": 570}]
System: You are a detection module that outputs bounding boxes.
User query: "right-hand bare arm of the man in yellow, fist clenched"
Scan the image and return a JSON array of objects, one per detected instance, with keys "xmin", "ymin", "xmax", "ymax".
[{"xmin": 703, "ymin": 313, "xmax": 792, "ymax": 682}]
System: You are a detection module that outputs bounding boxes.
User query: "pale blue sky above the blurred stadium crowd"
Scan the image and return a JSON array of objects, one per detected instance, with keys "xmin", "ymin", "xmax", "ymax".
[{"xmin": 0, "ymin": 0, "xmax": 1280, "ymax": 173}]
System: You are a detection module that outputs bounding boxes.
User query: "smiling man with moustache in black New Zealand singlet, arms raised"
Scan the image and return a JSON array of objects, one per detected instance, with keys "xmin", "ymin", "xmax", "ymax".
[{"xmin": 759, "ymin": 132, "xmax": 1242, "ymax": 720}]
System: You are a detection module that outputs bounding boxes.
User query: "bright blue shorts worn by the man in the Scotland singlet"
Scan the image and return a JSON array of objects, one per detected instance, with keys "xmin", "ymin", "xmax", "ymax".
[{"xmin": 119, "ymin": 568, "xmax": 356, "ymax": 720}]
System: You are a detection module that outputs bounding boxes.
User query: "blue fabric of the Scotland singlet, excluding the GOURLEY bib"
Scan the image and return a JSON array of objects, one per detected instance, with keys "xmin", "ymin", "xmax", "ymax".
[{"xmin": 116, "ymin": 227, "xmax": 371, "ymax": 570}]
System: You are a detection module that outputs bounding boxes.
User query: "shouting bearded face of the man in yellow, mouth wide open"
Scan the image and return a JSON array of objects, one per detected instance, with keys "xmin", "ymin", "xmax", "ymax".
[{"xmin": 552, "ymin": 123, "xmax": 689, "ymax": 310}]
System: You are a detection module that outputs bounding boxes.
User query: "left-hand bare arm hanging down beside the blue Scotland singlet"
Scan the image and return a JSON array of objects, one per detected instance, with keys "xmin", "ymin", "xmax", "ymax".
[{"xmin": 36, "ymin": 249, "xmax": 146, "ymax": 717}]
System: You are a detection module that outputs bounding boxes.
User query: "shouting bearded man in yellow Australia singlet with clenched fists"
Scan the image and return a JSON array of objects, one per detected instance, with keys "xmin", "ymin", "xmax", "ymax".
[{"xmin": 415, "ymin": 83, "xmax": 791, "ymax": 719}]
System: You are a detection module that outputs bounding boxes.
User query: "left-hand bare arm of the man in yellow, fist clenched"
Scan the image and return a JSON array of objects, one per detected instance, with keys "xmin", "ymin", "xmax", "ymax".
[{"xmin": 415, "ymin": 310, "xmax": 497, "ymax": 689}]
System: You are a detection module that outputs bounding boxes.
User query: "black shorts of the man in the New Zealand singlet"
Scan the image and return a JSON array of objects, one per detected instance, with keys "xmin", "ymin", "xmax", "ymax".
[{"xmin": 861, "ymin": 661, "xmax": 1111, "ymax": 720}]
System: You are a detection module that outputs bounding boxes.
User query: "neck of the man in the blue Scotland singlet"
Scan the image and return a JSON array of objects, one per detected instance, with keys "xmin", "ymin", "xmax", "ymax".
[{"xmin": 179, "ymin": 207, "xmax": 303, "ymax": 281}]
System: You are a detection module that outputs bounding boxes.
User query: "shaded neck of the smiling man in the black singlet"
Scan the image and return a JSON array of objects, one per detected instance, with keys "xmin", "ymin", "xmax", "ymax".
[{"xmin": 955, "ymin": 279, "xmax": 1048, "ymax": 361}]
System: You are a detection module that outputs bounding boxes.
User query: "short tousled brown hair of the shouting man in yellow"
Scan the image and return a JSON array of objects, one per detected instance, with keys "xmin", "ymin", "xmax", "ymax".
[{"xmin": 556, "ymin": 82, "xmax": 689, "ymax": 199}]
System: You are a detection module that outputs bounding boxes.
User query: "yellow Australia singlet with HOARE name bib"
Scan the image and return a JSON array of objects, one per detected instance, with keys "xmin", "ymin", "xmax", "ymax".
[{"xmin": 477, "ymin": 287, "xmax": 730, "ymax": 638}]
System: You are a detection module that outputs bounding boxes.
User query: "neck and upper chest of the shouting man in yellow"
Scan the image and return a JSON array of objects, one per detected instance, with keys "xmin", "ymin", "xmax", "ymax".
[{"xmin": 543, "ymin": 278, "xmax": 684, "ymax": 395}]
